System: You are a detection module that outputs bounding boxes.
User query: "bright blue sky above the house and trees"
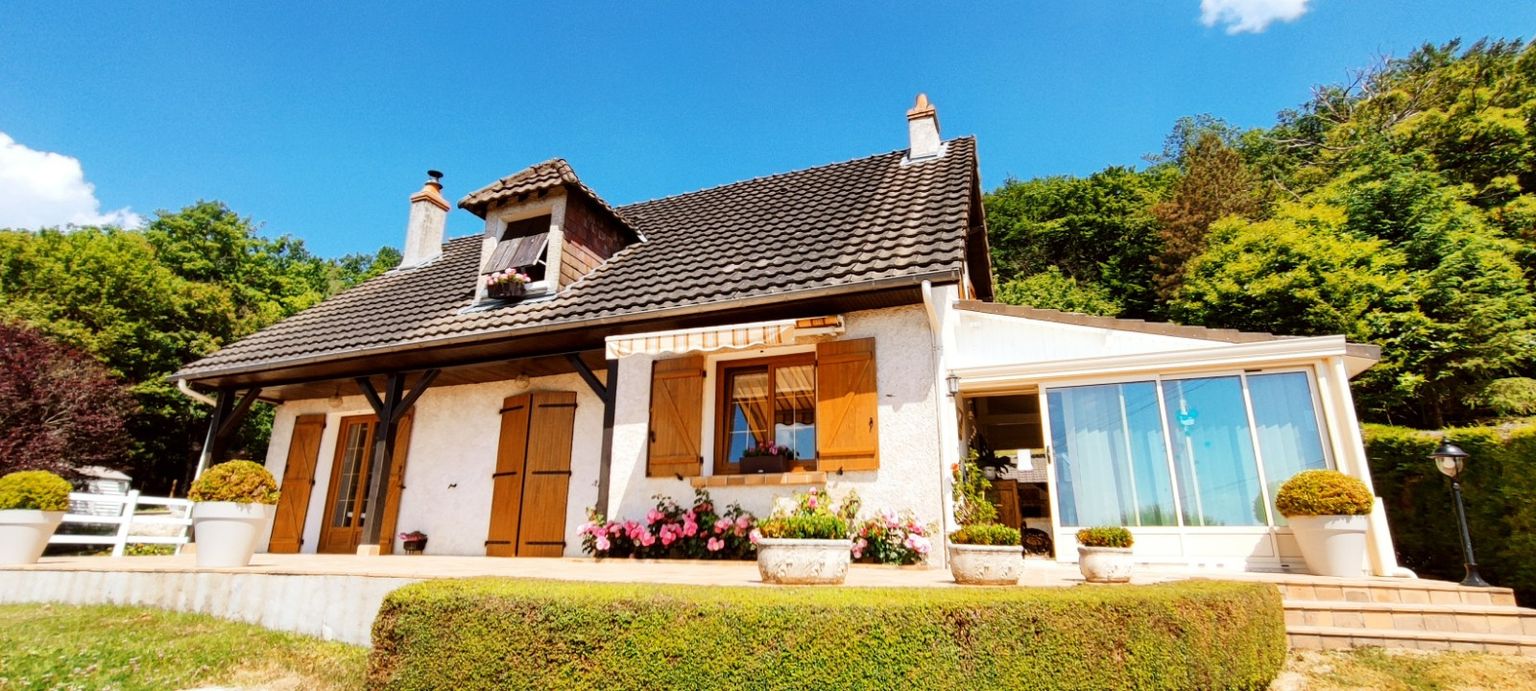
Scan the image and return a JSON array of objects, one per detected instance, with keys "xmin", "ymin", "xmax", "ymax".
[{"xmin": 0, "ymin": 0, "xmax": 1536, "ymax": 255}]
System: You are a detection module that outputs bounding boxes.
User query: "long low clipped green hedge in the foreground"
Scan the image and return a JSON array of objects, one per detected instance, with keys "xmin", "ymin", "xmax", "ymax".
[{"xmin": 369, "ymin": 579, "xmax": 1286, "ymax": 689}]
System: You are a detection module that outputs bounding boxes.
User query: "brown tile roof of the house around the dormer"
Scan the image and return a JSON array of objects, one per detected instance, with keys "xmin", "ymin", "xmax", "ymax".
[{"xmin": 174, "ymin": 138, "xmax": 977, "ymax": 379}]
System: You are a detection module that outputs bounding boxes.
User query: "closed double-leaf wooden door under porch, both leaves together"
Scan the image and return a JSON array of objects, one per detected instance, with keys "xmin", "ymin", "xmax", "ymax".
[{"xmin": 485, "ymin": 392, "xmax": 576, "ymax": 556}]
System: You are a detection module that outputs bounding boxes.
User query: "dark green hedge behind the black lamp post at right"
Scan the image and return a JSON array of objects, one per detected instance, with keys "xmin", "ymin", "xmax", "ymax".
[{"xmin": 1366, "ymin": 421, "xmax": 1536, "ymax": 602}]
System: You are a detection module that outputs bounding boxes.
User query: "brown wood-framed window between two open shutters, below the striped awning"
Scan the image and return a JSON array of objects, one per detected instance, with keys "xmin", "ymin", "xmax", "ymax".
[{"xmin": 714, "ymin": 353, "xmax": 816, "ymax": 474}]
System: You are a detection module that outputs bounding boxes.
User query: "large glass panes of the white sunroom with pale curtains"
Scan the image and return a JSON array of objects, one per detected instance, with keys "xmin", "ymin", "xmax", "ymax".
[{"xmin": 1046, "ymin": 372, "xmax": 1327, "ymax": 527}]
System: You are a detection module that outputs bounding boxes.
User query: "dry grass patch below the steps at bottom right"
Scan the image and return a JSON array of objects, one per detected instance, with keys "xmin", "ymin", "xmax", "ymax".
[{"xmin": 1270, "ymin": 648, "xmax": 1536, "ymax": 691}]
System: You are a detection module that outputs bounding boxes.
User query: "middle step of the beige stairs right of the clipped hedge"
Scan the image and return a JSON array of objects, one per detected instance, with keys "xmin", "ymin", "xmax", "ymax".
[{"xmin": 1286, "ymin": 600, "xmax": 1536, "ymax": 636}]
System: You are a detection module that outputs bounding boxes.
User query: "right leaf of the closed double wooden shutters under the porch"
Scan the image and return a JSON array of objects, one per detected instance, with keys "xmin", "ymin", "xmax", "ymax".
[{"xmin": 518, "ymin": 392, "xmax": 576, "ymax": 557}]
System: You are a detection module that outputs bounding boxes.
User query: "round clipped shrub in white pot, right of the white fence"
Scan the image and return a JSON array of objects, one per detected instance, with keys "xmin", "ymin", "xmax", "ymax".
[{"xmin": 187, "ymin": 461, "xmax": 278, "ymax": 568}]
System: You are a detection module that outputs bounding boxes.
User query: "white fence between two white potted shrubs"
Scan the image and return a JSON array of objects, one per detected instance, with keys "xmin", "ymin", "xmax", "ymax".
[{"xmin": 48, "ymin": 490, "xmax": 192, "ymax": 556}]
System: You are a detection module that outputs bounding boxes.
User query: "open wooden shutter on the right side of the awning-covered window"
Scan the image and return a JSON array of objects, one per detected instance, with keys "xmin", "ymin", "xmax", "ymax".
[{"xmin": 816, "ymin": 338, "xmax": 880, "ymax": 471}]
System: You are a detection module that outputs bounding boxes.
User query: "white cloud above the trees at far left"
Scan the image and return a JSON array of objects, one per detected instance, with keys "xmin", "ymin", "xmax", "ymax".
[{"xmin": 0, "ymin": 132, "xmax": 144, "ymax": 229}]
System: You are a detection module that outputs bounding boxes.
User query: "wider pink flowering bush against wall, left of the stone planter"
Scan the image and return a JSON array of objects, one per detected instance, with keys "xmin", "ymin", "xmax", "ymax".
[{"xmin": 578, "ymin": 490, "xmax": 757, "ymax": 559}]
